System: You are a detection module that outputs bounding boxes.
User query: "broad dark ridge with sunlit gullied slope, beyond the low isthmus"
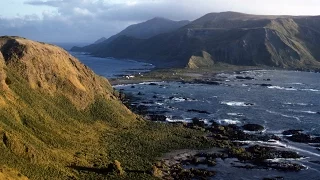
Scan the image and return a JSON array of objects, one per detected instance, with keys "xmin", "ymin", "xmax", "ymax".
[{"xmin": 75, "ymin": 12, "xmax": 320, "ymax": 69}]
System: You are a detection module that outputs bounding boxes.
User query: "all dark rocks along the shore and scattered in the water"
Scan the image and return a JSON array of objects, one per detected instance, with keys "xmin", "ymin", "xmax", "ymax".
[{"xmin": 113, "ymin": 69, "xmax": 320, "ymax": 179}]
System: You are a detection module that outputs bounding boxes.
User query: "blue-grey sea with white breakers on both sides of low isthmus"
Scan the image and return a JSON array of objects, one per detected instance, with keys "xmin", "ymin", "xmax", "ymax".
[{"xmin": 73, "ymin": 53, "xmax": 320, "ymax": 179}]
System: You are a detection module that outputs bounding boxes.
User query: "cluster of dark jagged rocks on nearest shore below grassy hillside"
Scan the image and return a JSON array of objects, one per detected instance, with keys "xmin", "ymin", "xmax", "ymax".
[{"xmin": 151, "ymin": 121, "xmax": 305, "ymax": 179}]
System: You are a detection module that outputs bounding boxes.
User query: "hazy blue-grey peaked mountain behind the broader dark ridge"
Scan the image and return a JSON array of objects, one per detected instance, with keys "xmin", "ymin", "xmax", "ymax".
[{"xmin": 71, "ymin": 17, "xmax": 189, "ymax": 52}]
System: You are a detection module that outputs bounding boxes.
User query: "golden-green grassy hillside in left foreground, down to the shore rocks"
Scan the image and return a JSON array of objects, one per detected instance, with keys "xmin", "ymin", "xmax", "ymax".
[{"xmin": 0, "ymin": 37, "xmax": 211, "ymax": 179}]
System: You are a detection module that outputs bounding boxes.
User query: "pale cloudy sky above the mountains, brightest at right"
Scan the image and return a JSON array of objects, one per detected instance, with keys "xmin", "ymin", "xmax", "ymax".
[{"xmin": 0, "ymin": 0, "xmax": 320, "ymax": 43}]
